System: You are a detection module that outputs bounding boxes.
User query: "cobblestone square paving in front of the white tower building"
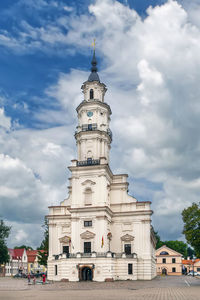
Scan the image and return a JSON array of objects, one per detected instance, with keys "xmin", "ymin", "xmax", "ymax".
[{"xmin": 0, "ymin": 276, "xmax": 200, "ymax": 300}]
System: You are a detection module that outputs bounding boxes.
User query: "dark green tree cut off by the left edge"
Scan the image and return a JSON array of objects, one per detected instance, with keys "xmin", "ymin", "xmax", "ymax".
[{"xmin": 0, "ymin": 220, "xmax": 11, "ymax": 264}]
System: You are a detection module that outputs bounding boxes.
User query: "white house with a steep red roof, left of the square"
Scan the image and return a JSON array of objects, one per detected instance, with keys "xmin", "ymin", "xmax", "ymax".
[{"xmin": 5, "ymin": 248, "xmax": 28, "ymax": 276}]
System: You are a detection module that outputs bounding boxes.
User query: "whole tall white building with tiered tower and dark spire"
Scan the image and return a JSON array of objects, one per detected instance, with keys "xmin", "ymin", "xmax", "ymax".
[{"xmin": 48, "ymin": 56, "xmax": 156, "ymax": 281}]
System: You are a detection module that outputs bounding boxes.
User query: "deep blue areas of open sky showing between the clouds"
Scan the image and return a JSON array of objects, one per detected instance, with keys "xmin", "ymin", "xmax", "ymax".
[{"xmin": 0, "ymin": 0, "xmax": 165, "ymax": 127}]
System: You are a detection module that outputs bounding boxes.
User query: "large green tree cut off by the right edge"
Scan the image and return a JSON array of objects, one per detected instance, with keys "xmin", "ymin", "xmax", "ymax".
[{"xmin": 182, "ymin": 203, "xmax": 200, "ymax": 257}]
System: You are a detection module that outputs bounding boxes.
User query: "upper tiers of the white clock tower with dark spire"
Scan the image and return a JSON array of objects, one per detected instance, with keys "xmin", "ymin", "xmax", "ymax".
[{"xmin": 75, "ymin": 51, "xmax": 112, "ymax": 165}]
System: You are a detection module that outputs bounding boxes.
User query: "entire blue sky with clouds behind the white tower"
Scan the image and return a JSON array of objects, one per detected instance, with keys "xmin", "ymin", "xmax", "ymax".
[{"xmin": 0, "ymin": 0, "xmax": 200, "ymax": 248}]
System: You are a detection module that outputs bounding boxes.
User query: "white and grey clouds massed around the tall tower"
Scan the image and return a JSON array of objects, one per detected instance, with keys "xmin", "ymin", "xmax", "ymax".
[{"xmin": 0, "ymin": 0, "xmax": 200, "ymax": 246}]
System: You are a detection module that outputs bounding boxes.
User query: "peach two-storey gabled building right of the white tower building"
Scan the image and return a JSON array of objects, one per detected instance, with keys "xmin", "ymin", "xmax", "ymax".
[{"xmin": 156, "ymin": 245, "xmax": 182, "ymax": 275}]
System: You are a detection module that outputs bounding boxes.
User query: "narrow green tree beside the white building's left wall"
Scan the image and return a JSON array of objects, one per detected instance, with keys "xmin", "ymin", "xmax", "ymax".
[{"xmin": 37, "ymin": 218, "xmax": 49, "ymax": 266}]
